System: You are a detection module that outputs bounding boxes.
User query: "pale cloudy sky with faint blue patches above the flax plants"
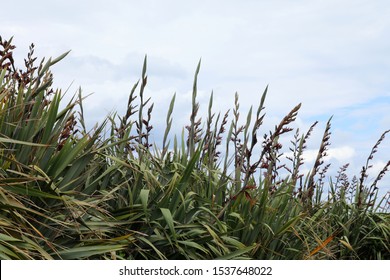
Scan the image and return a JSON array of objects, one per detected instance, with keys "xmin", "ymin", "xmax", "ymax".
[{"xmin": 0, "ymin": 0, "xmax": 390, "ymax": 201}]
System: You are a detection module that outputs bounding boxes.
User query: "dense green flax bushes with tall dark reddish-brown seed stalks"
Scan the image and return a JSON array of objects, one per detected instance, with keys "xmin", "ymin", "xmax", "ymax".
[{"xmin": 0, "ymin": 38, "xmax": 390, "ymax": 259}]
